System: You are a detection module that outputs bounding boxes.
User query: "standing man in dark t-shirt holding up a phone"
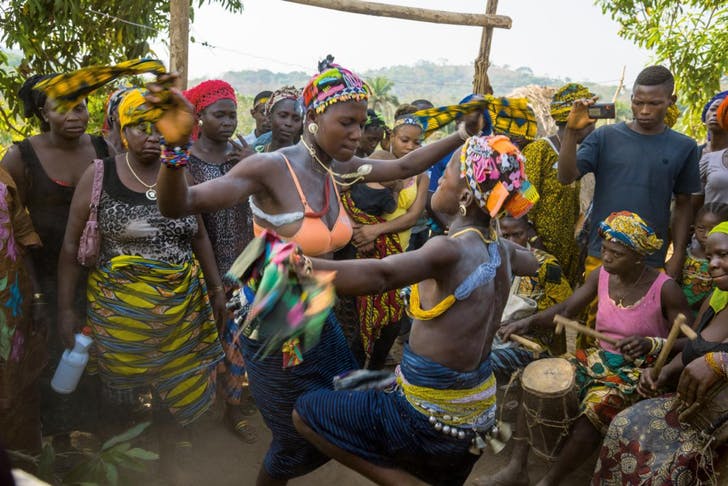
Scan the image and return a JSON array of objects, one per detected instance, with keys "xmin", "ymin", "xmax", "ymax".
[{"xmin": 559, "ymin": 66, "xmax": 700, "ymax": 278}]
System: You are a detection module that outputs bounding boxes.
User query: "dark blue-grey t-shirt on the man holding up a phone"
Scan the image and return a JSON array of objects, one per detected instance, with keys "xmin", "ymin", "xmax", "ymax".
[{"xmin": 577, "ymin": 123, "xmax": 701, "ymax": 267}]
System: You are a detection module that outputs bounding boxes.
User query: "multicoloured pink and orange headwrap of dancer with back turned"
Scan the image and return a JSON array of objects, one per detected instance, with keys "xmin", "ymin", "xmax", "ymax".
[{"xmin": 460, "ymin": 135, "xmax": 539, "ymax": 218}]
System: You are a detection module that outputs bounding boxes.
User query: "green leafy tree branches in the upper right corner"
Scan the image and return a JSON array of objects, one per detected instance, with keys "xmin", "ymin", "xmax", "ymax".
[{"xmin": 596, "ymin": 0, "xmax": 728, "ymax": 137}]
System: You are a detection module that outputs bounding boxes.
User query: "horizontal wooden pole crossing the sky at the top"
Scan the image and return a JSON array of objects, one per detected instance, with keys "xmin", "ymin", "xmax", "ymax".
[{"xmin": 284, "ymin": 0, "xmax": 511, "ymax": 29}]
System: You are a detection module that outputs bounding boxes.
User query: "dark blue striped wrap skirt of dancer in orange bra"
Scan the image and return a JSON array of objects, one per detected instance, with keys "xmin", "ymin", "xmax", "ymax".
[{"xmin": 240, "ymin": 312, "xmax": 358, "ymax": 480}]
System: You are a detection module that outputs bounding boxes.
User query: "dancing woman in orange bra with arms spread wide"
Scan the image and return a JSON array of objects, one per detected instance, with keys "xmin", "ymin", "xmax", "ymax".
[{"xmin": 148, "ymin": 59, "xmax": 486, "ymax": 484}]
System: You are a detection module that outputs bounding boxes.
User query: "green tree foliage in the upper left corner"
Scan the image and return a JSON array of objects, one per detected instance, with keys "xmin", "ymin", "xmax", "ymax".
[{"xmin": 0, "ymin": 0, "xmax": 243, "ymax": 142}]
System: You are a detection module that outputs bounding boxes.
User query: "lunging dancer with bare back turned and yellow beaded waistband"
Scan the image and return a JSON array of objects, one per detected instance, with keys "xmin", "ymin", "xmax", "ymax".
[{"xmin": 294, "ymin": 137, "xmax": 536, "ymax": 484}]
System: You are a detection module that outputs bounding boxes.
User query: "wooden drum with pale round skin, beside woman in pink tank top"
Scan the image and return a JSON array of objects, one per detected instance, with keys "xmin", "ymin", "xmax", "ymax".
[{"xmin": 521, "ymin": 358, "xmax": 579, "ymax": 461}]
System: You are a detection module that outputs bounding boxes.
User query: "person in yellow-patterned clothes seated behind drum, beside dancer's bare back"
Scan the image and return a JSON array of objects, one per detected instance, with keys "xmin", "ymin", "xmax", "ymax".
[{"xmin": 492, "ymin": 216, "xmax": 571, "ymax": 383}]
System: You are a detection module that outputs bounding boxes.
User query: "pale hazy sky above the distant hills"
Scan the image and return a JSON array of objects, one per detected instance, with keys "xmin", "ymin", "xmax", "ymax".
[{"xmin": 157, "ymin": 0, "xmax": 650, "ymax": 84}]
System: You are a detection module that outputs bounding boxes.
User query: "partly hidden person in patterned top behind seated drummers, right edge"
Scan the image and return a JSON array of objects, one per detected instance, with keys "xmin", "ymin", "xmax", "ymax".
[{"xmin": 680, "ymin": 202, "xmax": 728, "ymax": 313}]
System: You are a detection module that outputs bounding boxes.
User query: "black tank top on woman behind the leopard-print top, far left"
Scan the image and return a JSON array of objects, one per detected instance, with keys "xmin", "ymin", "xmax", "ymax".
[{"xmin": 16, "ymin": 135, "xmax": 109, "ymax": 294}]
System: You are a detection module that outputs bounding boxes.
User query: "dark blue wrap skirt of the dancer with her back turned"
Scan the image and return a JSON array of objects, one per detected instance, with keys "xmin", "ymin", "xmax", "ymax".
[{"xmin": 296, "ymin": 346, "xmax": 495, "ymax": 485}]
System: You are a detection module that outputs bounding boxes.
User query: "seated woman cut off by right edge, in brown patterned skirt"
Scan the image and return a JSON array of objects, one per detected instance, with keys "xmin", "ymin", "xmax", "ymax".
[{"xmin": 592, "ymin": 222, "xmax": 728, "ymax": 486}]
